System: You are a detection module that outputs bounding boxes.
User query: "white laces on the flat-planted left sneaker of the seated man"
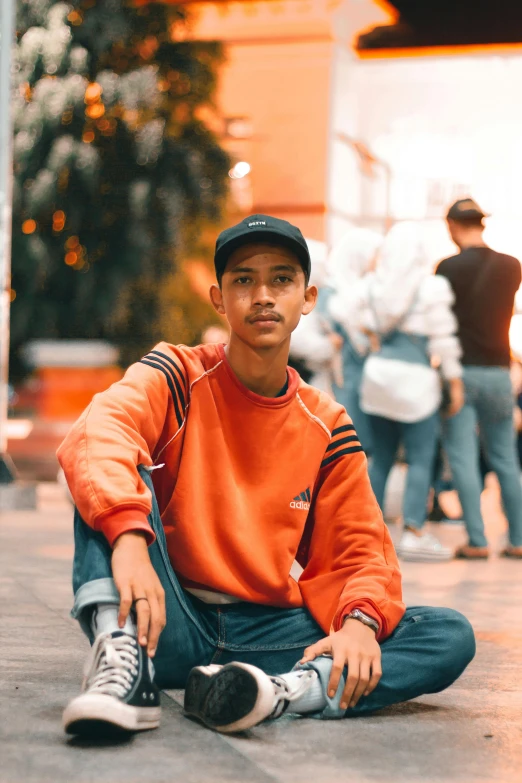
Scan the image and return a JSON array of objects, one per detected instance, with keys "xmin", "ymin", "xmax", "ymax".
[{"xmin": 82, "ymin": 633, "xmax": 139, "ymax": 698}]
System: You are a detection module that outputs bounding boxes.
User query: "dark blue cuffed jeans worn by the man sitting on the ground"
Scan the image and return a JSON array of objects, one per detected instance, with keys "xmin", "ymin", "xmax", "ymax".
[{"xmin": 72, "ymin": 467, "xmax": 475, "ymax": 718}]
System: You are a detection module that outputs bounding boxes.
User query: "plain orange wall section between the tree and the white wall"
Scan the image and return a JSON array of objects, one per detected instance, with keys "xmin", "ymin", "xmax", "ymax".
[{"xmin": 218, "ymin": 42, "xmax": 331, "ymax": 239}]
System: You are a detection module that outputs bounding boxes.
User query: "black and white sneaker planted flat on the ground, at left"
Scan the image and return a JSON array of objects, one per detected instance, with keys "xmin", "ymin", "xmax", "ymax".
[{"xmin": 63, "ymin": 631, "xmax": 161, "ymax": 735}]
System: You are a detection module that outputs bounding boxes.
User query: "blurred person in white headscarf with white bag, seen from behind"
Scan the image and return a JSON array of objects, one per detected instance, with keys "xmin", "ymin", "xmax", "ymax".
[{"xmin": 350, "ymin": 222, "xmax": 463, "ymax": 561}]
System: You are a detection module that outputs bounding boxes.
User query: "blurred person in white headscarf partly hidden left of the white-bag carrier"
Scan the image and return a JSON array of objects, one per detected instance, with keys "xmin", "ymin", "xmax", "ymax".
[{"xmin": 328, "ymin": 228, "xmax": 383, "ymax": 456}]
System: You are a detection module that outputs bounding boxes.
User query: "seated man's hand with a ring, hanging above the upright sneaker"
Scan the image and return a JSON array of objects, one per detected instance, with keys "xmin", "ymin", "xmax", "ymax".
[{"xmin": 112, "ymin": 532, "xmax": 166, "ymax": 658}]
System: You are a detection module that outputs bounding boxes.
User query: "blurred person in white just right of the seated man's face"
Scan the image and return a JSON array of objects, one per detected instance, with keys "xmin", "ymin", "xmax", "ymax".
[{"xmin": 290, "ymin": 239, "xmax": 343, "ymax": 394}]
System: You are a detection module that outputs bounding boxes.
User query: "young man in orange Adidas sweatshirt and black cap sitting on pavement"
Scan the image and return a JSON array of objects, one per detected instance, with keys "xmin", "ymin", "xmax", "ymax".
[{"xmin": 58, "ymin": 215, "xmax": 475, "ymax": 734}]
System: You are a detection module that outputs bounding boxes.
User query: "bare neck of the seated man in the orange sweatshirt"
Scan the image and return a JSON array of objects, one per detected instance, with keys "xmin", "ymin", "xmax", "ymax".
[{"xmin": 225, "ymin": 334, "xmax": 290, "ymax": 397}]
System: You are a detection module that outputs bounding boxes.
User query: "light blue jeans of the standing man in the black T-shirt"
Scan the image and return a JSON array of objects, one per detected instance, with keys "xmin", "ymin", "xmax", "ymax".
[{"xmin": 443, "ymin": 367, "xmax": 522, "ymax": 547}]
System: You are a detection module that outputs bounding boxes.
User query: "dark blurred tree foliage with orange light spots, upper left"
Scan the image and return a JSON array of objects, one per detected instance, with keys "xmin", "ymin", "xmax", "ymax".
[{"xmin": 11, "ymin": 0, "xmax": 229, "ymax": 374}]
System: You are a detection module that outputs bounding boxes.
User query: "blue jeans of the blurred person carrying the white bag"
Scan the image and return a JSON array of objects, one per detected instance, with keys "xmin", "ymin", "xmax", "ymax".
[{"xmin": 370, "ymin": 413, "xmax": 439, "ymax": 529}]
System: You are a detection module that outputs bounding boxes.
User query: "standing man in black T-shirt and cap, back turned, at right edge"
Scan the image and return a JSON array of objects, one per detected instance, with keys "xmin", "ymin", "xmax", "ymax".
[{"xmin": 437, "ymin": 198, "xmax": 522, "ymax": 559}]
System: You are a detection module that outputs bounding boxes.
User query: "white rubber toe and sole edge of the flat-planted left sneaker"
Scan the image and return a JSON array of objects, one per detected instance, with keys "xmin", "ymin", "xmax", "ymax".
[{"xmin": 62, "ymin": 694, "xmax": 161, "ymax": 734}]
